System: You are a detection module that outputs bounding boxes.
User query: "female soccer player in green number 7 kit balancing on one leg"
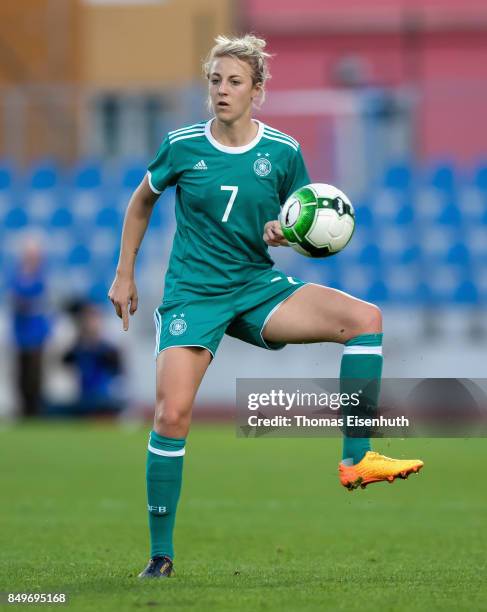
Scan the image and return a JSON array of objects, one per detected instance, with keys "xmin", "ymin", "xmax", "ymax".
[{"xmin": 109, "ymin": 35, "xmax": 422, "ymax": 578}]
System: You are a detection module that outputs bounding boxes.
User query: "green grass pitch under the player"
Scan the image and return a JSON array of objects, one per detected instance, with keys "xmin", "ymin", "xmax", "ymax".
[{"xmin": 0, "ymin": 423, "xmax": 487, "ymax": 612}]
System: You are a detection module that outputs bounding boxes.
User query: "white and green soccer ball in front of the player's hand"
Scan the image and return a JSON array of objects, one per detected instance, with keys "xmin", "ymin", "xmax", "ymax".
[{"xmin": 279, "ymin": 183, "xmax": 355, "ymax": 257}]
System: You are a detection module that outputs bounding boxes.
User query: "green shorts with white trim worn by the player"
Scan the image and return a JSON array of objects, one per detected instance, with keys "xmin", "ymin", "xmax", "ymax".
[{"xmin": 154, "ymin": 270, "xmax": 306, "ymax": 357}]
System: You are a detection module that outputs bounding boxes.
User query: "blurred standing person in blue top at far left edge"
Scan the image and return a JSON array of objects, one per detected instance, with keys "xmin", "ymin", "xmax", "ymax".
[{"xmin": 10, "ymin": 236, "xmax": 51, "ymax": 417}]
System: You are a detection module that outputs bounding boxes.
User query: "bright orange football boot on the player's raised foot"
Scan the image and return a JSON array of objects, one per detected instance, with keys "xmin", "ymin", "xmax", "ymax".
[{"xmin": 338, "ymin": 451, "xmax": 424, "ymax": 491}]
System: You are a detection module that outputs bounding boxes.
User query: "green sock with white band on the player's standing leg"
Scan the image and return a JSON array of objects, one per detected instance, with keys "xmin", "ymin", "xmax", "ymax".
[{"xmin": 146, "ymin": 431, "xmax": 186, "ymax": 559}]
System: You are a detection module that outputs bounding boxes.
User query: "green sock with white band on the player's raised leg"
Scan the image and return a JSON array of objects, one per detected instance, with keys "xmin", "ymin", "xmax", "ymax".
[{"xmin": 340, "ymin": 334, "xmax": 382, "ymax": 465}]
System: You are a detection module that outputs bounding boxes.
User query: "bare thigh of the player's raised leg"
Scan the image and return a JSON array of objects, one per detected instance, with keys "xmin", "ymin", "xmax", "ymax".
[{"xmin": 263, "ymin": 284, "xmax": 381, "ymax": 344}]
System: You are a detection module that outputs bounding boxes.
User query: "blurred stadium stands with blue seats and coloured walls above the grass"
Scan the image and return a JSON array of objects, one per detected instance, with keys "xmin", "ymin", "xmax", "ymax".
[{"xmin": 0, "ymin": 0, "xmax": 487, "ymax": 414}]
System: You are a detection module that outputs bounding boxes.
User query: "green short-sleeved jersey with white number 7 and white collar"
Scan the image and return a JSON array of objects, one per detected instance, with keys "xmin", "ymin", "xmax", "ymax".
[{"xmin": 148, "ymin": 120, "xmax": 311, "ymax": 302}]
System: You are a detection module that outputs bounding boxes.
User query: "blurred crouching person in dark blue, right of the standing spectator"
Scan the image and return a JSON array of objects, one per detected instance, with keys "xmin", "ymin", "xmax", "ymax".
[{"xmin": 47, "ymin": 302, "xmax": 125, "ymax": 416}]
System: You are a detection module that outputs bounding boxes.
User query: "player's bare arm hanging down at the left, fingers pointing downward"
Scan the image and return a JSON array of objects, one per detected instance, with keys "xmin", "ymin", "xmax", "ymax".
[{"xmin": 108, "ymin": 176, "xmax": 159, "ymax": 331}]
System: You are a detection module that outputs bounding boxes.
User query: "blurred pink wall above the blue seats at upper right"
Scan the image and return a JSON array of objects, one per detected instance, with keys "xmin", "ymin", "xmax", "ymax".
[{"xmin": 243, "ymin": 0, "xmax": 487, "ymax": 162}]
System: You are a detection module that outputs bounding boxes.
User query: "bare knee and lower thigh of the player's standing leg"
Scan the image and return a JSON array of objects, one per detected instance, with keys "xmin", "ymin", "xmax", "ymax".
[{"xmin": 154, "ymin": 347, "xmax": 211, "ymax": 438}]
